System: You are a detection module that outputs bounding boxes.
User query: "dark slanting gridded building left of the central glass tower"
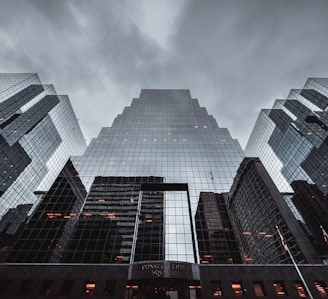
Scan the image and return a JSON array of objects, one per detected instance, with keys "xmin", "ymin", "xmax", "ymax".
[{"xmin": 6, "ymin": 160, "xmax": 86, "ymax": 263}]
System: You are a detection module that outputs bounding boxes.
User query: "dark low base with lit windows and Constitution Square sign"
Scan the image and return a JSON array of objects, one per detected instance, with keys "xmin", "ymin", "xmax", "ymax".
[{"xmin": 0, "ymin": 261, "xmax": 328, "ymax": 299}]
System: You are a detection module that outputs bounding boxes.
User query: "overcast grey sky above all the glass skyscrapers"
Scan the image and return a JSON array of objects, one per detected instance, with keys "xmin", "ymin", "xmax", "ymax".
[{"xmin": 0, "ymin": 0, "xmax": 328, "ymax": 148}]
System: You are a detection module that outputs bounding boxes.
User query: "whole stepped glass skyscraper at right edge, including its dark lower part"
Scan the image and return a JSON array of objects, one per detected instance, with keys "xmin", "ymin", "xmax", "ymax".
[{"xmin": 245, "ymin": 78, "xmax": 328, "ymax": 258}]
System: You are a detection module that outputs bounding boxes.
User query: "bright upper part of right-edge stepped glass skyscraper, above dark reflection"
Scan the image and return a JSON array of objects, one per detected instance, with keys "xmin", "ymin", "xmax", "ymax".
[{"xmin": 245, "ymin": 78, "xmax": 328, "ymax": 194}]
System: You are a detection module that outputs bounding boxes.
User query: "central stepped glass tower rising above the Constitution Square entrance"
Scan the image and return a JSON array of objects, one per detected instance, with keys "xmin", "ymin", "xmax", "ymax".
[{"xmin": 70, "ymin": 90, "xmax": 244, "ymax": 262}]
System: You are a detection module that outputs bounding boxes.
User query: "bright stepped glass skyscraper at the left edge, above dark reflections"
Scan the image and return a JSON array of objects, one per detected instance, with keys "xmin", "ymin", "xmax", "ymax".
[{"xmin": 0, "ymin": 73, "xmax": 86, "ymax": 217}]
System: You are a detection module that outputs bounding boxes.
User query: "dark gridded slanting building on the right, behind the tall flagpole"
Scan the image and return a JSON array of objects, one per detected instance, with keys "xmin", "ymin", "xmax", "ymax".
[{"xmin": 224, "ymin": 158, "xmax": 322, "ymax": 264}]
